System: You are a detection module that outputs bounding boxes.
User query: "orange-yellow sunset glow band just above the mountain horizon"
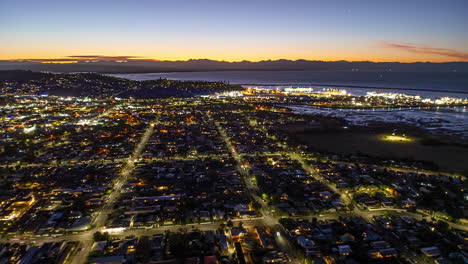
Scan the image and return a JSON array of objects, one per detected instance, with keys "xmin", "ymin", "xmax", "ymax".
[{"xmin": 0, "ymin": 43, "xmax": 468, "ymax": 63}]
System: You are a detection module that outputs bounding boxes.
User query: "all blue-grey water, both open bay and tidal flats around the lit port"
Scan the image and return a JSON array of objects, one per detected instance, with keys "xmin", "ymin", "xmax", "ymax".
[{"xmin": 110, "ymin": 71, "xmax": 468, "ymax": 137}]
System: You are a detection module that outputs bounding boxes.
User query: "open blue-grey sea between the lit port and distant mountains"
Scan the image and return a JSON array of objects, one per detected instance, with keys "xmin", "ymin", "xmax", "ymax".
[{"xmin": 110, "ymin": 71, "xmax": 468, "ymax": 98}]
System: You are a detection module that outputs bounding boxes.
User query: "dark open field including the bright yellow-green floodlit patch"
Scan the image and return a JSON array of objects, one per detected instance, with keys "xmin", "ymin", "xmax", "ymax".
[{"xmin": 295, "ymin": 131, "xmax": 468, "ymax": 174}]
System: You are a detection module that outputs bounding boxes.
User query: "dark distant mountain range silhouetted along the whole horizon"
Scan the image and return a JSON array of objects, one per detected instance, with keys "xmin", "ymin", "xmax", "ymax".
[{"xmin": 0, "ymin": 59, "xmax": 468, "ymax": 73}]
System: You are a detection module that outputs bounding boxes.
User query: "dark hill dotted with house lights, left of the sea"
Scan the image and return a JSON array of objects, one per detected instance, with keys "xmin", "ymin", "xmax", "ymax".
[{"xmin": 0, "ymin": 70, "xmax": 243, "ymax": 98}]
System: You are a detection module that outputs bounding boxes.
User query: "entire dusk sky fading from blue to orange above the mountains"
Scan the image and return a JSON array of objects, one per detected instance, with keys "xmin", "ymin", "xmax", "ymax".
[{"xmin": 0, "ymin": 0, "xmax": 468, "ymax": 62}]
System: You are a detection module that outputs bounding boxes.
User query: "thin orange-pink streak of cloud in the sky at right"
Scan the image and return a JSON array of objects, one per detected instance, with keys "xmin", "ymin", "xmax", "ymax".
[{"xmin": 378, "ymin": 41, "xmax": 468, "ymax": 61}]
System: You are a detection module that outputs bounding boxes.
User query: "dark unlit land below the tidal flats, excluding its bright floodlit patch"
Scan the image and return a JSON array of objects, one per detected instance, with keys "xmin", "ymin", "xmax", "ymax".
[{"xmin": 285, "ymin": 116, "xmax": 468, "ymax": 175}]
